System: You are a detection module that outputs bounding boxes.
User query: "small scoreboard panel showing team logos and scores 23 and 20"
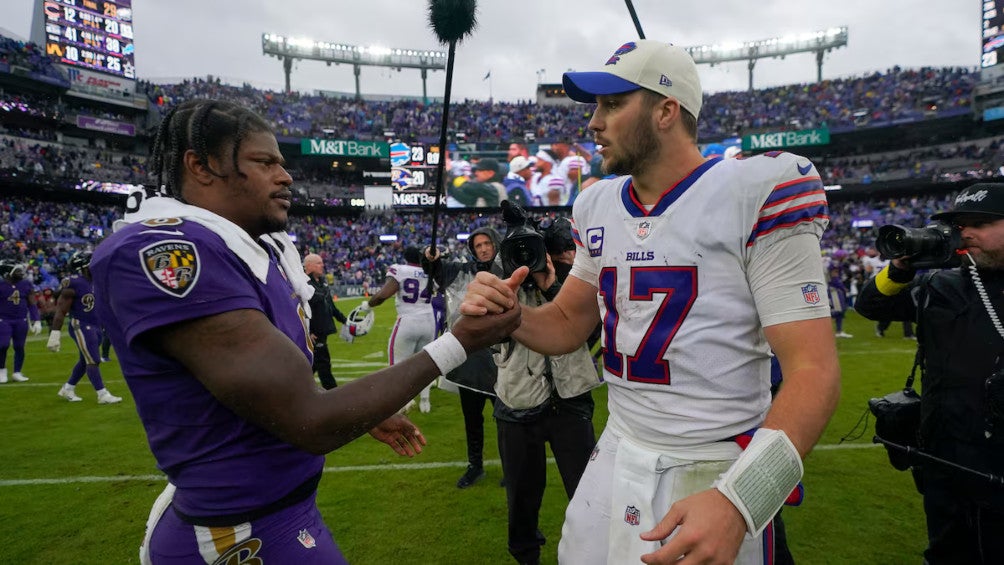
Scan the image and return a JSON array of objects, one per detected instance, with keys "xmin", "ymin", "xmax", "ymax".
[{"xmin": 391, "ymin": 142, "xmax": 445, "ymax": 208}]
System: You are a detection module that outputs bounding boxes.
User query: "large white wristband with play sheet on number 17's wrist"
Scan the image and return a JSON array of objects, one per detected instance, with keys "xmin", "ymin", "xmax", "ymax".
[{"xmin": 715, "ymin": 428, "xmax": 804, "ymax": 537}]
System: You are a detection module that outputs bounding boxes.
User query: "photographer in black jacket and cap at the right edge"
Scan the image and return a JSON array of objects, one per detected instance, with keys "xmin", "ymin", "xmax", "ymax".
[{"xmin": 855, "ymin": 184, "xmax": 1004, "ymax": 565}]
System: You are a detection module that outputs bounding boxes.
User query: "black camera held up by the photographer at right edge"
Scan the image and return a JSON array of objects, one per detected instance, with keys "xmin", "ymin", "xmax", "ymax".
[{"xmin": 875, "ymin": 222, "xmax": 962, "ymax": 269}]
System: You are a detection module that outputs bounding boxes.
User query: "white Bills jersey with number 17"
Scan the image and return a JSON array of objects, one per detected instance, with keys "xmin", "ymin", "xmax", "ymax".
[{"xmin": 571, "ymin": 152, "xmax": 829, "ymax": 450}]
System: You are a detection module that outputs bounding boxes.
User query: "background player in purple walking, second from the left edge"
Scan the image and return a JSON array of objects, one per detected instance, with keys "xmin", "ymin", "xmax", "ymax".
[{"xmin": 46, "ymin": 251, "xmax": 122, "ymax": 404}]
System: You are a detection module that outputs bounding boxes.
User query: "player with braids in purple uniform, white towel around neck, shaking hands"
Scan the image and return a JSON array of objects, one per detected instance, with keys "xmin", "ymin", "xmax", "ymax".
[{"xmin": 91, "ymin": 99, "xmax": 519, "ymax": 565}]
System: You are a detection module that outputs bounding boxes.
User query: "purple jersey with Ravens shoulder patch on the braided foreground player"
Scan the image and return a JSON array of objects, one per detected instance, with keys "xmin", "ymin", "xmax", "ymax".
[{"xmin": 90, "ymin": 220, "xmax": 324, "ymax": 517}]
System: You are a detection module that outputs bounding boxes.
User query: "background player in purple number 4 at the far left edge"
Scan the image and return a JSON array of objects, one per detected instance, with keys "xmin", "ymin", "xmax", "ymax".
[{"xmin": 0, "ymin": 261, "xmax": 42, "ymax": 384}]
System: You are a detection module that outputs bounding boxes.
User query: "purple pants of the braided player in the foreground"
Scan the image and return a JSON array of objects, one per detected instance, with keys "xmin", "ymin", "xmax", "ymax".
[{"xmin": 141, "ymin": 488, "xmax": 348, "ymax": 565}]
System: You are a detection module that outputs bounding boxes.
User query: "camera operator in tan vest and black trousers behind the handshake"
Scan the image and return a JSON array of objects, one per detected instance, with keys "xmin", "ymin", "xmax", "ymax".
[{"xmin": 495, "ymin": 202, "xmax": 601, "ymax": 563}]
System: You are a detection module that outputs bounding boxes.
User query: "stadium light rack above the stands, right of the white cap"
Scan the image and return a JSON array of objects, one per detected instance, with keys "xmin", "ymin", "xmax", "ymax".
[{"xmin": 684, "ymin": 26, "xmax": 847, "ymax": 92}]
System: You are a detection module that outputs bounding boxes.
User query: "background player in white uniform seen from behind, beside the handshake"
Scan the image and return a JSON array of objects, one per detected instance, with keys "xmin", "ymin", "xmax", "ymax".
[{"xmin": 362, "ymin": 247, "xmax": 436, "ymax": 412}]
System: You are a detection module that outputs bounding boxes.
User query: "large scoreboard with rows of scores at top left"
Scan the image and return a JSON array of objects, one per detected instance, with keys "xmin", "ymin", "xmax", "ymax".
[{"xmin": 41, "ymin": 0, "xmax": 136, "ymax": 79}]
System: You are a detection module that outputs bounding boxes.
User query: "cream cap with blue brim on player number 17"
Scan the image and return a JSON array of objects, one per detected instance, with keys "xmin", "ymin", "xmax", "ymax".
[{"xmin": 561, "ymin": 39, "xmax": 703, "ymax": 117}]
